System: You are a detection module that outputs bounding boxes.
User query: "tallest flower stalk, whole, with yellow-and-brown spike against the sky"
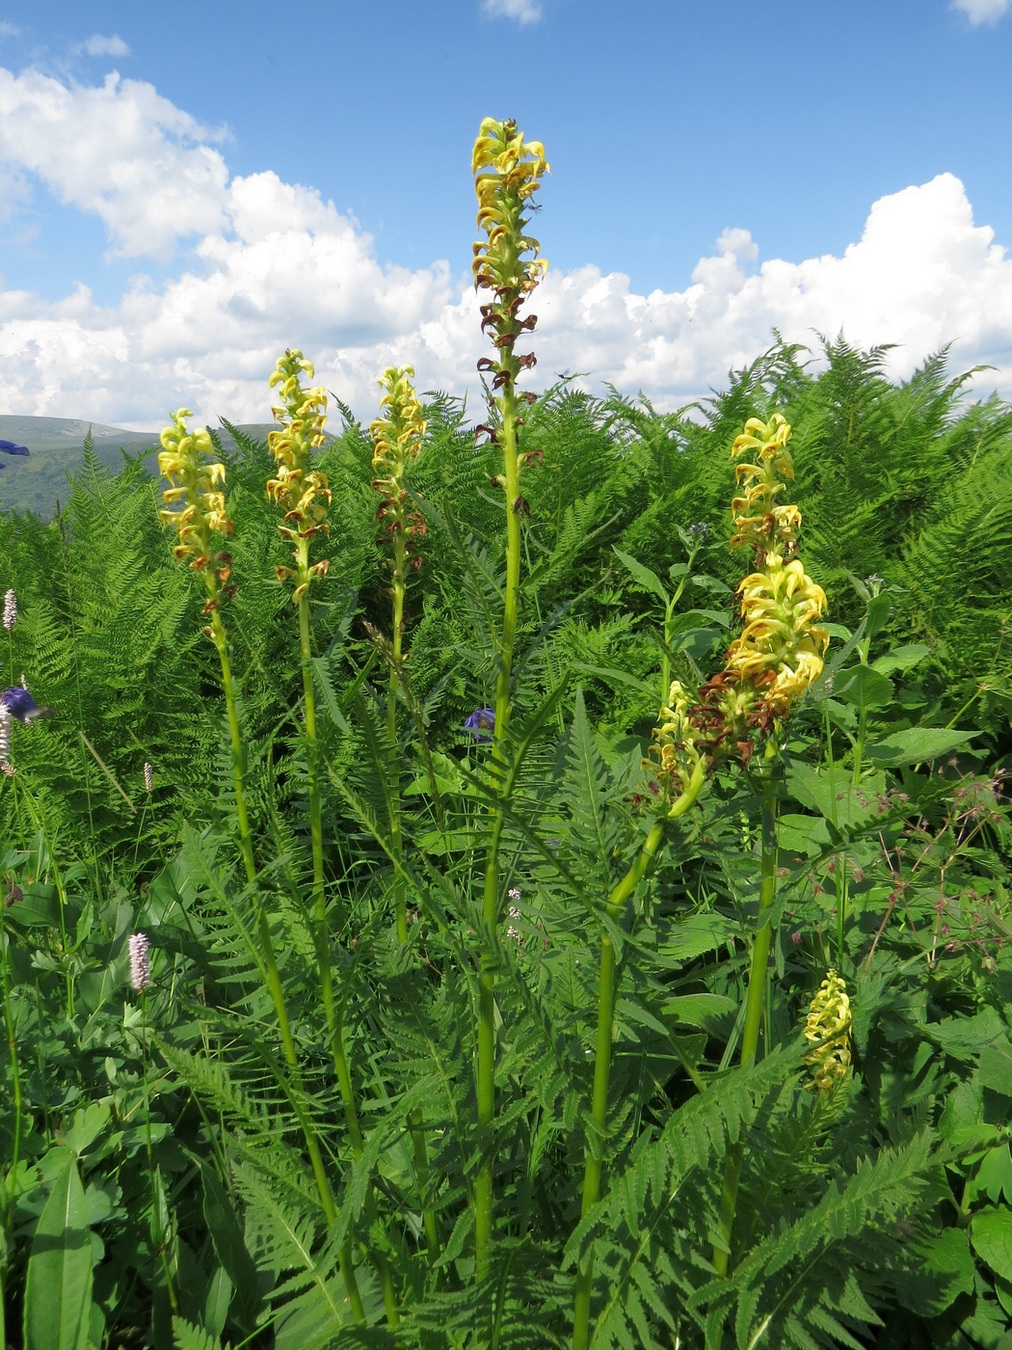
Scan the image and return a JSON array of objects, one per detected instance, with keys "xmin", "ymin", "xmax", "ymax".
[{"xmin": 471, "ymin": 117, "xmax": 548, "ymax": 1283}]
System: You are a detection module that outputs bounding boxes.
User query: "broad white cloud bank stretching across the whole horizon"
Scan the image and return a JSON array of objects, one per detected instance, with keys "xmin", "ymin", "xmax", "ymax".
[{"xmin": 0, "ymin": 70, "xmax": 1012, "ymax": 429}]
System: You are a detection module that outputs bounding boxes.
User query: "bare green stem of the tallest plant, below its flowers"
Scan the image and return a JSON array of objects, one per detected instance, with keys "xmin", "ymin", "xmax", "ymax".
[{"xmin": 474, "ymin": 372, "xmax": 521, "ymax": 1283}]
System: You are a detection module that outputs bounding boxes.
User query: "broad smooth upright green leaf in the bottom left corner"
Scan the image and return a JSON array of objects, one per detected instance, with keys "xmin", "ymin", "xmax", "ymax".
[{"xmin": 24, "ymin": 1154, "xmax": 92, "ymax": 1350}]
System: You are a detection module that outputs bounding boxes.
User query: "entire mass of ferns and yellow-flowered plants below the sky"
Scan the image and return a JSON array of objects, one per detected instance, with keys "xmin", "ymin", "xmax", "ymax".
[{"xmin": 0, "ymin": 119, "xmax": 1012, "ymax": 1350}]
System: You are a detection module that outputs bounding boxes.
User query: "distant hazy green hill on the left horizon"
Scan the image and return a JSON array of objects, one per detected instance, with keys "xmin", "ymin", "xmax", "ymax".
[{"xmin": 0, "ymin": 416, "xmax": 277, "ymax": 520}]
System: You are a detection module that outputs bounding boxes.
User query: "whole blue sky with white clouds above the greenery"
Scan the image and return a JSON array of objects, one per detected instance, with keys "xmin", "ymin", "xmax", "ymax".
[{"xmin": 0, "ymin": 0, "xmax": 1012, "ymax": 428}]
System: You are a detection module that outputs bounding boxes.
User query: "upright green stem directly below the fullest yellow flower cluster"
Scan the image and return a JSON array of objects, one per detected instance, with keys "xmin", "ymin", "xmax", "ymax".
[{"xmin": 712, "ymin": 737, "xmax": 780, "ymax": 1276}]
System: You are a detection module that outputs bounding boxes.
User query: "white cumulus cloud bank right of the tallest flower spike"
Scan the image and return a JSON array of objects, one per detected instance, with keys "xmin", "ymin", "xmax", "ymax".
[{"xmin": 538, "ymin": 174, "xmax": 1012, "ymax": 398}]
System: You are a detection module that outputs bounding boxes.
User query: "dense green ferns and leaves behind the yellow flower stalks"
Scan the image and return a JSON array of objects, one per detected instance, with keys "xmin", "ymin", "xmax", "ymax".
[{"xmin": 0, "ymin": 340, "xmax": 1012, "ymax": 1350}]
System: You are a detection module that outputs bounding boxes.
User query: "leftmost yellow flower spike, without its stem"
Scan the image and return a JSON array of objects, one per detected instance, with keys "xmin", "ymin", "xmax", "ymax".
[{"xmin": 158, "ymin": 408, "xmax": 233, "ymax": 614}]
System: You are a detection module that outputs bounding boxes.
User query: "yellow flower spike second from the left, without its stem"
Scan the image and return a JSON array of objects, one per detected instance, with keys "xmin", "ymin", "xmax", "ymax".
[{"xmin": 267, "ymin": 348, "xmax": 331, "ymax": 539}]
